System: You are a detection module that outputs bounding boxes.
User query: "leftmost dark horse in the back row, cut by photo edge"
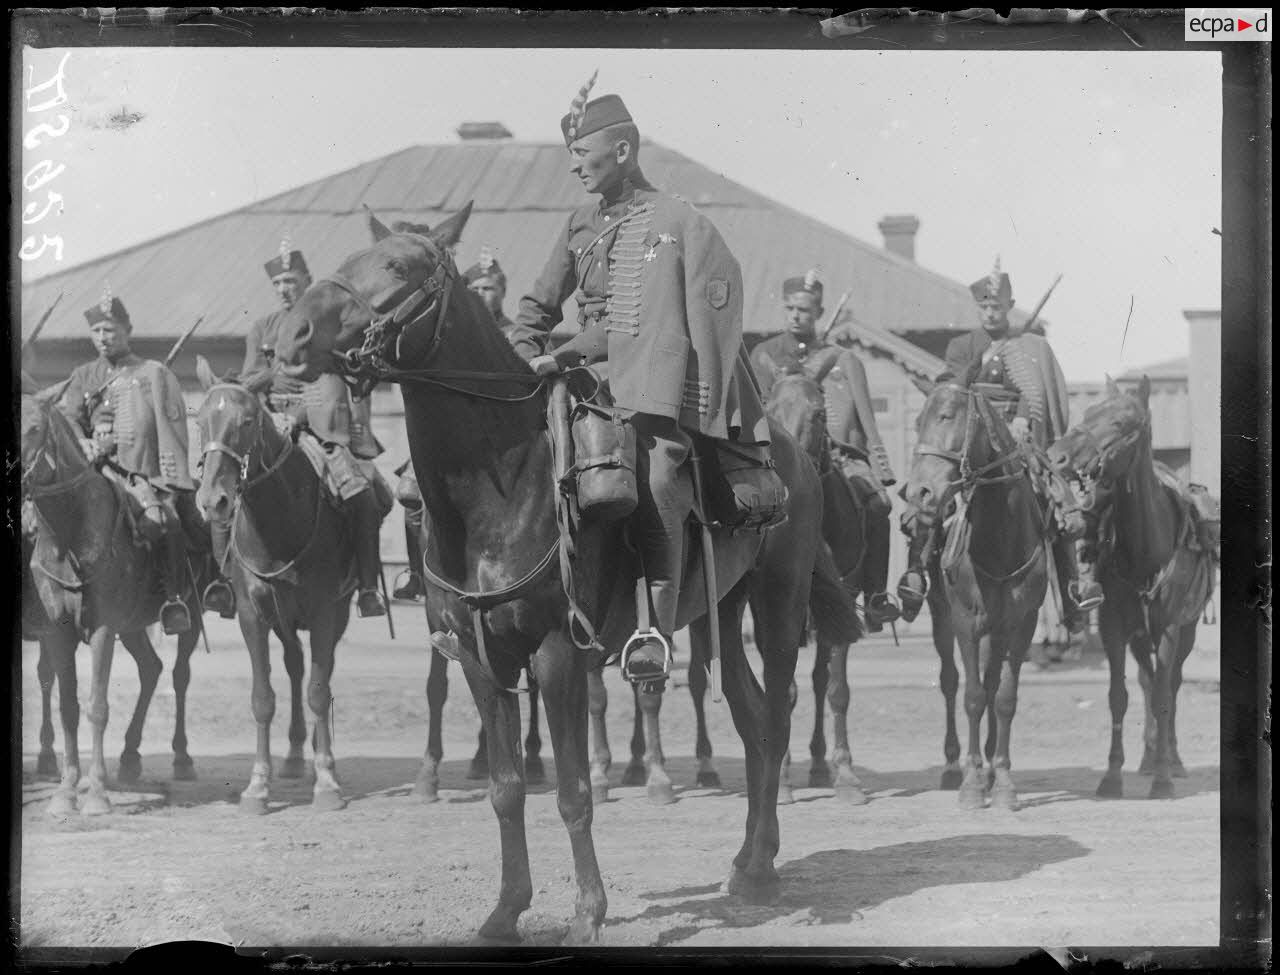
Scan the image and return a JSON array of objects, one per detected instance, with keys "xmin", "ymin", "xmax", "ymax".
[{"xmin": 22, "ymin": 395, "xmax": 207, "ymax": 815}]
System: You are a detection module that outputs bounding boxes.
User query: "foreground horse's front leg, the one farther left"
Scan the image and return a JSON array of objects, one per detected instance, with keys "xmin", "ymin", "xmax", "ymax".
[{"xmin": 462, "ymin": 654, "xmax": 529, "ymax": 944}]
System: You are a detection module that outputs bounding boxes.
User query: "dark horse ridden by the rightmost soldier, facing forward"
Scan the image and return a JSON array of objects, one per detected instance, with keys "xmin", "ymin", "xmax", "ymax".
[{"xmin": 904, "ymin": 384, "xmax": 1048, "ymax": 809}]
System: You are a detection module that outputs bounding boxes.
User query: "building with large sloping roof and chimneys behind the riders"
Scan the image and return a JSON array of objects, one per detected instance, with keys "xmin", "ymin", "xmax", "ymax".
[{"xmin": 22, "ymin": 129, "xmax": 1054, "ymax": 596}]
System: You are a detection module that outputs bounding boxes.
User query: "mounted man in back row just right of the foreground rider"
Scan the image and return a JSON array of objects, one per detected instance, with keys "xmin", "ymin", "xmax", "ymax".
[{"xmin": 751, "ymin": 270, "xmax": 899, "ymax": 632}]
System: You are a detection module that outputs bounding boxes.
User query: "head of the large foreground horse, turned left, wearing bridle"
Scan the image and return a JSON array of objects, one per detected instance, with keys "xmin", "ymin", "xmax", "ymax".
[{"xmin": 275, "ymin": 203, "xmax": 471, "ymax": 381}]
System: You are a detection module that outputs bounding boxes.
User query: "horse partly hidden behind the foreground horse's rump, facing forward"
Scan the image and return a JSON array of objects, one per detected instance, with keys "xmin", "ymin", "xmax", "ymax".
[{"xmin": 767, "ymin": 372, "xmax": 867, "ymax": 805}]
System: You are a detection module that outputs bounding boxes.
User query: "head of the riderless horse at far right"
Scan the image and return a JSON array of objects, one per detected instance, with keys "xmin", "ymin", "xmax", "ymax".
[{"xmin": 1048, "ymin": 376, "xmax": 1151, "ymax": 504}]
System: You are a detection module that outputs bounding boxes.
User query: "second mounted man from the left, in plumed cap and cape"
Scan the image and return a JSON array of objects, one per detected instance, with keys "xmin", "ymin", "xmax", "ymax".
[{"xmin": 205, "ymin": 238, "xmax": 387, "ymax": 617}]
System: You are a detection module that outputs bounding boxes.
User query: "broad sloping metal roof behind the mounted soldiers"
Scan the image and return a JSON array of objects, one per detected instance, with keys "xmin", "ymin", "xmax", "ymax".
[{"xmin": 22, "ymin": 141, "xmax": 1021, "ymax": 354}]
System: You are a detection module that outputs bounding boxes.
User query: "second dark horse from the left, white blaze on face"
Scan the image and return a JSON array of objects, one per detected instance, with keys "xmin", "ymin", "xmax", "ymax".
[{"xmin": 196, "ymin": 358, "xmax": 356, "ymax": 814}]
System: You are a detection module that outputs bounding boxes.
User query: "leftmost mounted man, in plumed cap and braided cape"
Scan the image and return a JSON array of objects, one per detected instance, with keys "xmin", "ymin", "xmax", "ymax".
[{"xmin": 58, "ymin": 288, "xmax": 209, "ymax": 633}]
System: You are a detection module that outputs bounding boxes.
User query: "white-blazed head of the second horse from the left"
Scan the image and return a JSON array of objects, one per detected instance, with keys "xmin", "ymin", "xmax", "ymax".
[{"xmin": 196, "ymin": 356, "xmax": 275, "ymax": 522}]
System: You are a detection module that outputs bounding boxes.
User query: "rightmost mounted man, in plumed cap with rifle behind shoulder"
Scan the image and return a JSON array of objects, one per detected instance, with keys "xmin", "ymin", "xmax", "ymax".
[{"xmin": 899, "ymin": 257, "xmax": 1102, "ymax": 632}]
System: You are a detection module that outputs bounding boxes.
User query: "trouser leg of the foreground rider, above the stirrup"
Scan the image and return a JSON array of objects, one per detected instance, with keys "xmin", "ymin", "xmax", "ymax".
[{"xmin": 632, "ymin": 415, "xmax": 694, "ymax": 637}]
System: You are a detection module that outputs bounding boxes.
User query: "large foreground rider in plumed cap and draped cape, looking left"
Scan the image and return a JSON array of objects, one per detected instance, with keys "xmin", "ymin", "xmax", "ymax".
[{"xmin": 516, "ymin": 74, "xmax": 785, "ymax": 683}]
